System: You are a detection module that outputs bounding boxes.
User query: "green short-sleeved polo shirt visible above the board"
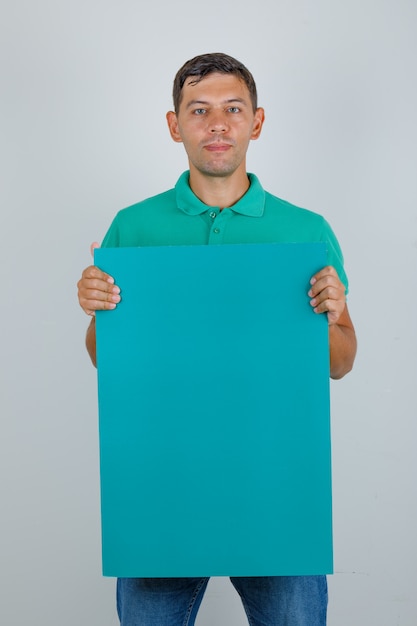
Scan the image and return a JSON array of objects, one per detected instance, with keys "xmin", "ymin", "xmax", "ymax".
[{"xmin": 102, "ymin": 171, "xmax": 348, "ymax": 290}]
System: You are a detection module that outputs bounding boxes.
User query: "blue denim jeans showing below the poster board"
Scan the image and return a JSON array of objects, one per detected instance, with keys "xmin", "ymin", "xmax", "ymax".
[{"xmin": 117, "ymin": 576, "xmax": 327, "ymax": 626}]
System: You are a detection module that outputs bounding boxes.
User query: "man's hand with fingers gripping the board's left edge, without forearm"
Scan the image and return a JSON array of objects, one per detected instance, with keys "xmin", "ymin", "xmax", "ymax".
[{"xmin": 77, "ymin": 244, "xmax": 121, "ymax": 315}]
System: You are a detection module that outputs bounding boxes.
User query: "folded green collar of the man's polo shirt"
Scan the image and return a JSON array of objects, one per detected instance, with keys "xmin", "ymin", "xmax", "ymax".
[{"xmin": 175, "ymin": 170, "xmax": 265, "ymax": 217}]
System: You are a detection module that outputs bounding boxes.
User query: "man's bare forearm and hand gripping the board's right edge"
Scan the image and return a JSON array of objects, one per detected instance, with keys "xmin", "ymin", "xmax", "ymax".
[{"xmin": 308, "ymin": 266, "xmax": 357, "ymax": 379}]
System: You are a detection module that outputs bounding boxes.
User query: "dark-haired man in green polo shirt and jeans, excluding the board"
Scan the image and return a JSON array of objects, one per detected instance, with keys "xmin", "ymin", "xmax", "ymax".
[{"xmin": 78, "ymin": 54, "xmax": 356, "ymax": 626}]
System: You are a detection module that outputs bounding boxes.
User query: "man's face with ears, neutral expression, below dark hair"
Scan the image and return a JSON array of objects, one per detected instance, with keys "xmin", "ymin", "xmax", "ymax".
[{"xmin": 167, "ymin": 74, "xmax": 264, "ymax": 177}]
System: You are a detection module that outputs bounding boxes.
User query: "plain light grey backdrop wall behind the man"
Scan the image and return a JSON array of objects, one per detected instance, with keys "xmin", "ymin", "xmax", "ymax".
[{"xmin": 0, "ymin": 0, "xmax": 417, "ymax": 626}]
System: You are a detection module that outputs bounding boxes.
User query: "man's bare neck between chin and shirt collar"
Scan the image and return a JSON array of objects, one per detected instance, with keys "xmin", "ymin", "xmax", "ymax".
[{"xmin": 190, "ymin": 166, "xmax": 250, "ymax": 209}]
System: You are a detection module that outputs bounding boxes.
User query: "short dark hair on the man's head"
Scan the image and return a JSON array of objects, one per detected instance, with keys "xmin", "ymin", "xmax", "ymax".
[{"xmin": 172, "ymin": 52, "xmax": 258, "ymax": 113}]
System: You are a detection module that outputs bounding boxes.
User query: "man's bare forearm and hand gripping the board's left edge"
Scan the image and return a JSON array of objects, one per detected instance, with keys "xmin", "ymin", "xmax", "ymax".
[{"xmin": 77, "ymin": 265, "xmax": 121, "ymax": 366}]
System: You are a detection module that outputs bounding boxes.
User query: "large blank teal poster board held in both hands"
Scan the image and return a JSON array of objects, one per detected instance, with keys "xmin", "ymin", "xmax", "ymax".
[{"xmin": 95, "ymin": 244, "xmax": 333, "ymax": 577}]
